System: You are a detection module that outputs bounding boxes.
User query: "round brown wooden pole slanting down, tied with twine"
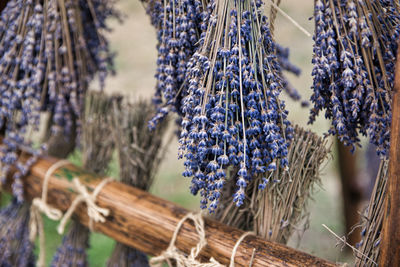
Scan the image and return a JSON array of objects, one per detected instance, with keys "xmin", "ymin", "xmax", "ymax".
[{"xmin": 6, "ymin": 153, "xmax": 337, "ymax": 267}]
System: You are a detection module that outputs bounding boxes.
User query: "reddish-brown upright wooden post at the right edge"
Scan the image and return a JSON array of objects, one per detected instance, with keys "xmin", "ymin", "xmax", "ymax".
[{"xmin": 379, "ymin": 43, "xmax": 400, "ymax": 267}]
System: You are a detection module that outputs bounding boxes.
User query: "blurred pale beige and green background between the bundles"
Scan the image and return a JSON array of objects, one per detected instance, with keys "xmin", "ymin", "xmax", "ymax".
[{"xmin": 0, "ymin": 0, "xmax": 372, "ymax": 266}]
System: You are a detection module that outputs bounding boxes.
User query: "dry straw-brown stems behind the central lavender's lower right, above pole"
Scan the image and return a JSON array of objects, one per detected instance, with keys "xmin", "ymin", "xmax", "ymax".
[{"xmin": 215, "ymin": 126, "xmax": 329, "ymax": 243}]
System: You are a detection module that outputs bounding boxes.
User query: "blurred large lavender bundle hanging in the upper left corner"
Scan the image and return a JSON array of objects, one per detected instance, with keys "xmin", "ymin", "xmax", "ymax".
[{"xmin": 0, "ymin": 0, "xmax": 116, "ymax": 201}]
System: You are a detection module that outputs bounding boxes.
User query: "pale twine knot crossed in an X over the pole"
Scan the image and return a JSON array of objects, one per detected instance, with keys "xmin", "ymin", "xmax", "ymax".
[{"xmin": 57, "ymin": 177, "xmax": 113, "ymax": 235}]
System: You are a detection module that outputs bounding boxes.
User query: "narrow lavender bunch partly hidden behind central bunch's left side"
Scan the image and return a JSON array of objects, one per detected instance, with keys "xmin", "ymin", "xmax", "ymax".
[{"xmin": 147, "ymin": 0, "xmax": 209, "ymax": 129}]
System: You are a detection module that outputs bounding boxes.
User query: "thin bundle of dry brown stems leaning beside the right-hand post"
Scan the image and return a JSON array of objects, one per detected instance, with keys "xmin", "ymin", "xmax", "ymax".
[{"xmin": 355, "ymin": 160, "xmax": 389, "ymax": 267}]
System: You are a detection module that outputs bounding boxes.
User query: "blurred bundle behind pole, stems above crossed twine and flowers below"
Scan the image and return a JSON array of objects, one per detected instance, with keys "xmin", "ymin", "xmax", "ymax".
[{"xmin": 51, "ymin": 91, "xmax": 114, "ymax": 267}]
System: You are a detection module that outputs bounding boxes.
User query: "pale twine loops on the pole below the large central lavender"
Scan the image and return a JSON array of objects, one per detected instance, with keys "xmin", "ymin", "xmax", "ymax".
[{"xmin": 150, "ymin": 213, "xmax": 255, "ymax": 267}]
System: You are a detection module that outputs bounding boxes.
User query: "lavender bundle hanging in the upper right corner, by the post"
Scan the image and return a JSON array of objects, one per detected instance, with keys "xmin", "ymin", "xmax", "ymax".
[{"xmin": 310, "ymin": 0, "xmax": 400, "ymax": 156}]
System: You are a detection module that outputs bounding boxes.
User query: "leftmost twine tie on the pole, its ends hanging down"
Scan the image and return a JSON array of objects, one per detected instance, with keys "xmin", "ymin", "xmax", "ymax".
[{"xmin": 29, "ymin": 160, "xmax": 70, "ymax": 267}]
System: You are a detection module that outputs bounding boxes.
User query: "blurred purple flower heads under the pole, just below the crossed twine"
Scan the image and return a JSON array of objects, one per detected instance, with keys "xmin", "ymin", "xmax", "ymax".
[{"xmin": 50, "ymin": 222, "xmax": 89, "ymax": 267}]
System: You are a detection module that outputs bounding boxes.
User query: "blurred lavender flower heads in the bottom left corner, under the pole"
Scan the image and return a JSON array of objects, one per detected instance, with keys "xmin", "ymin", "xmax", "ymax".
[{"xmin": 0, "ymin": 199, "xmax": 35, "ymax": 267}]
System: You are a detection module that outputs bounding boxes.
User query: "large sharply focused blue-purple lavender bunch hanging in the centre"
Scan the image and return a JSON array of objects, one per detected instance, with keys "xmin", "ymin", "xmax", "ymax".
[{"xmin": 179, "ymin": 0, "xmax": 292, "ymax": 211}]
